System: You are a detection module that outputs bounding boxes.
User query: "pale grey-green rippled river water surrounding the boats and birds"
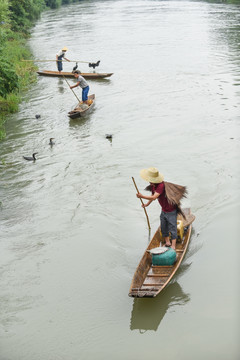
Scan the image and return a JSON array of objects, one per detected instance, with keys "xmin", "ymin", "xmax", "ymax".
[{"xmin": 0, "ymin": 0, "xmax": 240, "ymax": 360}]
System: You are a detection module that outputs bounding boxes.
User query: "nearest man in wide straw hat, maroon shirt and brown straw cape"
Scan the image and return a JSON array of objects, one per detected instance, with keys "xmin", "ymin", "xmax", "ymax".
[{"xmin": 137, "ymin": 167, "xmax": 186, "ymax": 250}]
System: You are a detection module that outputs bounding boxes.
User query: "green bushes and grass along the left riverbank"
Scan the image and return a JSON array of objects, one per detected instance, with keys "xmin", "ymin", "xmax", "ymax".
[{"xmin": 0, "ymin": 0, "xmax": 80, "ymax": 140}]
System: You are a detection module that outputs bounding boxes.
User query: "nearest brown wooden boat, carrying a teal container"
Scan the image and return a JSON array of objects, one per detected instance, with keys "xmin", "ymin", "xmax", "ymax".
[{"xmin": 128, "ymin": 209, "xmax": 195, "ymax": 297}]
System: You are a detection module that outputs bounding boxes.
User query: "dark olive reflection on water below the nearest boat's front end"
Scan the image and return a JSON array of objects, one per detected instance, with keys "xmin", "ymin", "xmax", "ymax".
[{"xmin": 130, "ymin": 282, "xmax": 190, "ymax": 333}]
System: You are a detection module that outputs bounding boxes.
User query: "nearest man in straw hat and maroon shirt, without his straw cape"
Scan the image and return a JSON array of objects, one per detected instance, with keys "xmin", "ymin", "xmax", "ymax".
[{"xmin": 137, "ymin": 167, "xmax": 177, "ymax": 250}]
